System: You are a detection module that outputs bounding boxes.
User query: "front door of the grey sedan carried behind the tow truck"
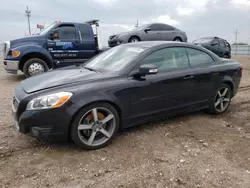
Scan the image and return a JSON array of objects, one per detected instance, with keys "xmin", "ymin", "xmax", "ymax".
[{"xmin": 142, "ymin": 24, "xmax": 162, "ymax": 41}]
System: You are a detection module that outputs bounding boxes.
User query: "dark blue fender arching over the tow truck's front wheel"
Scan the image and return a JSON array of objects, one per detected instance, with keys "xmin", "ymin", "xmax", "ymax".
[{"xmin": 12, "ymin": 44, "xmax": 53, "ymax": 67}]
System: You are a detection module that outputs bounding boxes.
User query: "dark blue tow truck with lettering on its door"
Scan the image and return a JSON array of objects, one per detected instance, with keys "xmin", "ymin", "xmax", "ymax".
[{"xmin": 3, "ymin": 20, "xmax": 106, "ymax": 77}]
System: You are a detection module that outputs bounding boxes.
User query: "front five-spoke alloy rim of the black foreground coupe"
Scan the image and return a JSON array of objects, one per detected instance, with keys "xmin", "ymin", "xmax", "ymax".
[{"xmin": 77, "ymin": 107, "xmax": 116, "ymax": 146}]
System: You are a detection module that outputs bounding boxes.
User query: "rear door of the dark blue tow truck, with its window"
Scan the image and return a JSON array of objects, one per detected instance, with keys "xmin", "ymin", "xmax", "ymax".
[{"xmin": 77, "ymin": 24, "xmax": 97, "ymax": 59}]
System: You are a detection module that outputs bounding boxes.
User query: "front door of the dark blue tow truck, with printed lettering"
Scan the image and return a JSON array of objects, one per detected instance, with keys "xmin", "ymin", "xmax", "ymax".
[{"xmin": 47, "ymin": 24, "xmax": 79, "ymax": 66}]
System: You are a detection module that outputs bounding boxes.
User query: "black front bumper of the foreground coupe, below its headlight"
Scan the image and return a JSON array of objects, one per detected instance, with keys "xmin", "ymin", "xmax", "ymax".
[{"xmin": 12, "ymin": 104, "xmax": 72, "ymax": 141}]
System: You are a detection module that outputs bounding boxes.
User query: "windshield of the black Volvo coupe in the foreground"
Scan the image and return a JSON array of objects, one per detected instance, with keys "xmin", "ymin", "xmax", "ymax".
[{"xmin": 84, "ymin": 45, "xmax": 146, "ymax": 72}]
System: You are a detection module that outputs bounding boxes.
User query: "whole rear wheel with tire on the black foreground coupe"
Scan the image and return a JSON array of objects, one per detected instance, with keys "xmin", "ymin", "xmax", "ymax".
[{"xmin": 208, "ymin": 84, "xmax": 232, "ymax": 115}]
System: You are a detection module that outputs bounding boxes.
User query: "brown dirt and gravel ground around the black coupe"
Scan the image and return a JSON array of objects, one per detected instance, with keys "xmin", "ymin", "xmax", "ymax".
[{"xmin": 0, "ymin": 57, "xmax": 250, "ymax": 188}]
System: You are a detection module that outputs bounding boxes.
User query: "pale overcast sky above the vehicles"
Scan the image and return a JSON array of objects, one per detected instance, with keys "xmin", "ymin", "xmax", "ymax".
[{"xmin": 0, "ymin": 0, "xmax": 250, "ymax": 45}]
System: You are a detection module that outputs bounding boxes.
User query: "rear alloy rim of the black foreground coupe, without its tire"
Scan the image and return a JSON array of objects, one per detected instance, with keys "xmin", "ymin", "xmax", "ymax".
[{"xmin": 214, "ymin": 87, "xmax": 231, "ymax": 112}]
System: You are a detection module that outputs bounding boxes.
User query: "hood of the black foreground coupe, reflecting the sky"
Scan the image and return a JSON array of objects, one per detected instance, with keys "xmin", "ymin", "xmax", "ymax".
[{"xmin": 20, "ymin": 66, "xmax": 116, "ymax": 93}]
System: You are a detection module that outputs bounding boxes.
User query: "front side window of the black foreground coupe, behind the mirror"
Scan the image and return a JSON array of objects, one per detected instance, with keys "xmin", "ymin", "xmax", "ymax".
[{"xmin": 141, "ymin": 47, "xmax": 189, "ymax": 72}]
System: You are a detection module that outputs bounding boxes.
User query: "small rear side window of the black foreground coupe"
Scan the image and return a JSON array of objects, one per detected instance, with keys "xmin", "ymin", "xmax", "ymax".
[{"xmin": 187, "ymin": 48, "xmax": 214, "ymax": 67}]
